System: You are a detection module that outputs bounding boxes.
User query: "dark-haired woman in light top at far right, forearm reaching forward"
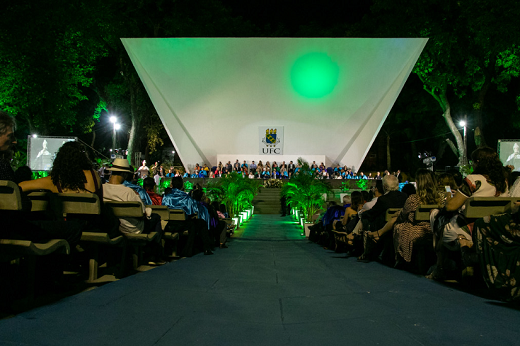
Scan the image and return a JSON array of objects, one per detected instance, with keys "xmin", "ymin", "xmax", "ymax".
[{"xmin": 428, "ymin": 147, "xmax": 509, "ymax": 279}]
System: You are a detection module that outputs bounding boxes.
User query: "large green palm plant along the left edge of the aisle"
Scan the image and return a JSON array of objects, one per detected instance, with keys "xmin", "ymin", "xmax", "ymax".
[{"xmin": 206, "ymin": 172, "xmax": 262, "ymax": 215}]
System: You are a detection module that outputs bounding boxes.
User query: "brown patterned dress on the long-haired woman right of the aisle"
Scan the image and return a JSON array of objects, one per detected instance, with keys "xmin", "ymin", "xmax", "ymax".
[{"xmin": 394, "ymin": 193, "xmax": 444, "ymax": 262}]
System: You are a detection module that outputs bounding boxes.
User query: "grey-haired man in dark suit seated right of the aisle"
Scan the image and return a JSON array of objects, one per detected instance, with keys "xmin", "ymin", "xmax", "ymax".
[{"xmin": 359, "ymin": 174, "xmax": 408, "ymax": 264}]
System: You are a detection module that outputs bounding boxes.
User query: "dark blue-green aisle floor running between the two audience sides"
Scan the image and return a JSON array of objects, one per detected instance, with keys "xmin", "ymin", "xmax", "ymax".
[{"xmin": 0, "ymin": 215, "xmax": 520, "ymax": 346}]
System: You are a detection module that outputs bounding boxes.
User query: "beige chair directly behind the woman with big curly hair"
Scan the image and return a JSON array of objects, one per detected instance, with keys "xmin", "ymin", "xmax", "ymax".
[{"xmin": 57, "ymin": 193, "xmax": 126, "ymax": 282}]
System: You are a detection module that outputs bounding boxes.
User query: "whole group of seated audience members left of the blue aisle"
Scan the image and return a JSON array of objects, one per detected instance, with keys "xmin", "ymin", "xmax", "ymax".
[{"xmin": 0, "ymin": 113, "xmax": 232, "ymax": 302}]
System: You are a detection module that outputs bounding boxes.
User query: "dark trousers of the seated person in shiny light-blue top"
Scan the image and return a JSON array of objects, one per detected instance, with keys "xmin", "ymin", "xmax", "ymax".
[{"xmin": 166, "ymin": 219, "xmax": 213, "ymax": 257}]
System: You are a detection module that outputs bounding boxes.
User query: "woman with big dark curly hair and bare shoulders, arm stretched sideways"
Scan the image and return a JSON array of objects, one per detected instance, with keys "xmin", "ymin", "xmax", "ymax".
[{"xmin": 20, "ymin": 142, "xmax": 103, "ymax": 196}]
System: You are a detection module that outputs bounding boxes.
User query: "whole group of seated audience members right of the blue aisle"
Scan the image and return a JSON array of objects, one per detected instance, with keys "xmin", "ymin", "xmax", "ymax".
[{"xmin": 310, "ymin": 148, "xmax": 520, "ymax": 301}]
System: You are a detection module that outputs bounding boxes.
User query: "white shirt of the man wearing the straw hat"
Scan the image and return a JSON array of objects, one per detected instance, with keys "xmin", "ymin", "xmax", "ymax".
[{"xmin": 103, "ymin": 183, "xmax": 145, "ymax": 233}]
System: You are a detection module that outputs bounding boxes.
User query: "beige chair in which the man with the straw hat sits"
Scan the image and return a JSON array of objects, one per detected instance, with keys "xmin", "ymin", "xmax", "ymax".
[{"xmin": 105, "ymin": 201, "xmax": 159, "ymax": 270}]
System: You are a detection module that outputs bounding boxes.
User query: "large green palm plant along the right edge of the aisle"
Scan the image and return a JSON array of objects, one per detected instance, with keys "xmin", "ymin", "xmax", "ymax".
[{"xmin": 282, "ymin": 158, "xmax": 330, "ymax": 222}]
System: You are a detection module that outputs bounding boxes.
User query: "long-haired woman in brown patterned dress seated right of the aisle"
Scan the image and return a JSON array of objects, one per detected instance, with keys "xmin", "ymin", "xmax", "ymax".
[{"xmin": 368, "ymin": 168, "xmax": 445, "ymax": 263}]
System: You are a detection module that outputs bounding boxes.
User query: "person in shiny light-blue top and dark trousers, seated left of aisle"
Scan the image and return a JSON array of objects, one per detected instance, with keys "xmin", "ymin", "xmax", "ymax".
[{"xmin": 162, "ymin": 177, "xmax": 213, "ymax": 257}]
